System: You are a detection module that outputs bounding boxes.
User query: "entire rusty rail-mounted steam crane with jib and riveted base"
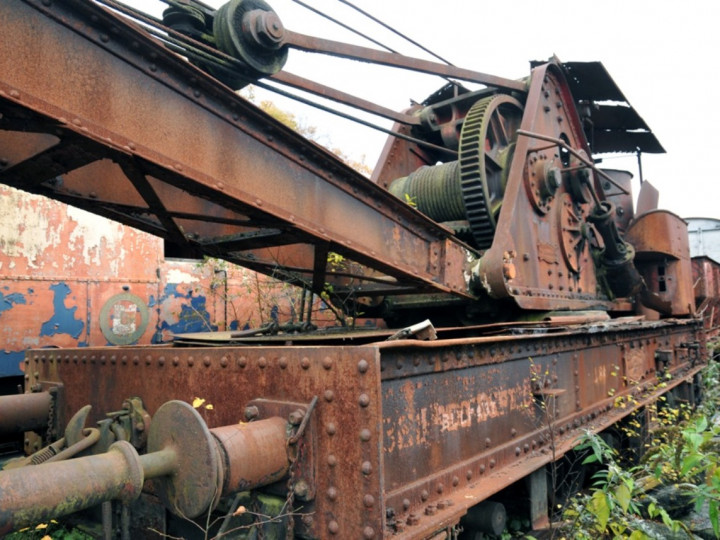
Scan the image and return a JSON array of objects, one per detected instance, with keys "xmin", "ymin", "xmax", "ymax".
[{"xmin": 0, "ymin": 0, "xmax": 706, "ymax": 539}]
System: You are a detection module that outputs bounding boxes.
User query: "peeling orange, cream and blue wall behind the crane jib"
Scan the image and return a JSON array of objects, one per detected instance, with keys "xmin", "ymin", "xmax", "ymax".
[{"xmin": 0, "ymin": 186, "xmax": 348, "ymax": 376}]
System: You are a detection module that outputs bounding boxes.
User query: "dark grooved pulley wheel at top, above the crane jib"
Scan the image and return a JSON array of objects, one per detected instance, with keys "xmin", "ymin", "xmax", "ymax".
[{"xmin": 213, "ymin": 0, "xmax": 288, "ymax": 76}]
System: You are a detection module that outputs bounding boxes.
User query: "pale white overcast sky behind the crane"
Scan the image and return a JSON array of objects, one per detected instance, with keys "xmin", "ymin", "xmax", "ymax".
[{"xmin": 125, "ymin": 0, "xmax": 720, "ymax": 218}]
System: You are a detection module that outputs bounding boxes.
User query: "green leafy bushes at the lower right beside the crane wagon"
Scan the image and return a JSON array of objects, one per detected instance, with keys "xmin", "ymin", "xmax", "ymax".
[{"xmin": 561, "ymin": 363, "xmax": 720, "ymax": 540}]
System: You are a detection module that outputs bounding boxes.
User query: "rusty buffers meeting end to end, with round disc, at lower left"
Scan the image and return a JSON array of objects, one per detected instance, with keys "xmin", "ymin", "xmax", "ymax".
[{"xmin": 0, "ymin": 401, "xmax": 290, "ymax": 536}]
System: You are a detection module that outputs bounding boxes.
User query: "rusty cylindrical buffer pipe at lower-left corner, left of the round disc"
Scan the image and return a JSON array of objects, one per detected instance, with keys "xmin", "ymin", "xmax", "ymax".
[{"xmin": 0, "ymin": 441, "xmax": 144, "ymax": 536}]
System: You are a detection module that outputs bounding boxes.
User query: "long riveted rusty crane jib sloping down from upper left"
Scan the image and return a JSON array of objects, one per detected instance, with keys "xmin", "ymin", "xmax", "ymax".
[{"xmin": 0, "ymin": 0, "xmax": 478, "ymax": 304}]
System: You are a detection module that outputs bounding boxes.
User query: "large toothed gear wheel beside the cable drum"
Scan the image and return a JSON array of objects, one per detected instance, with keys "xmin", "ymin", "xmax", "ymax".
[{"xmin": 459, "ymin": 94, "xmax": 523, "ymax": 249}]
